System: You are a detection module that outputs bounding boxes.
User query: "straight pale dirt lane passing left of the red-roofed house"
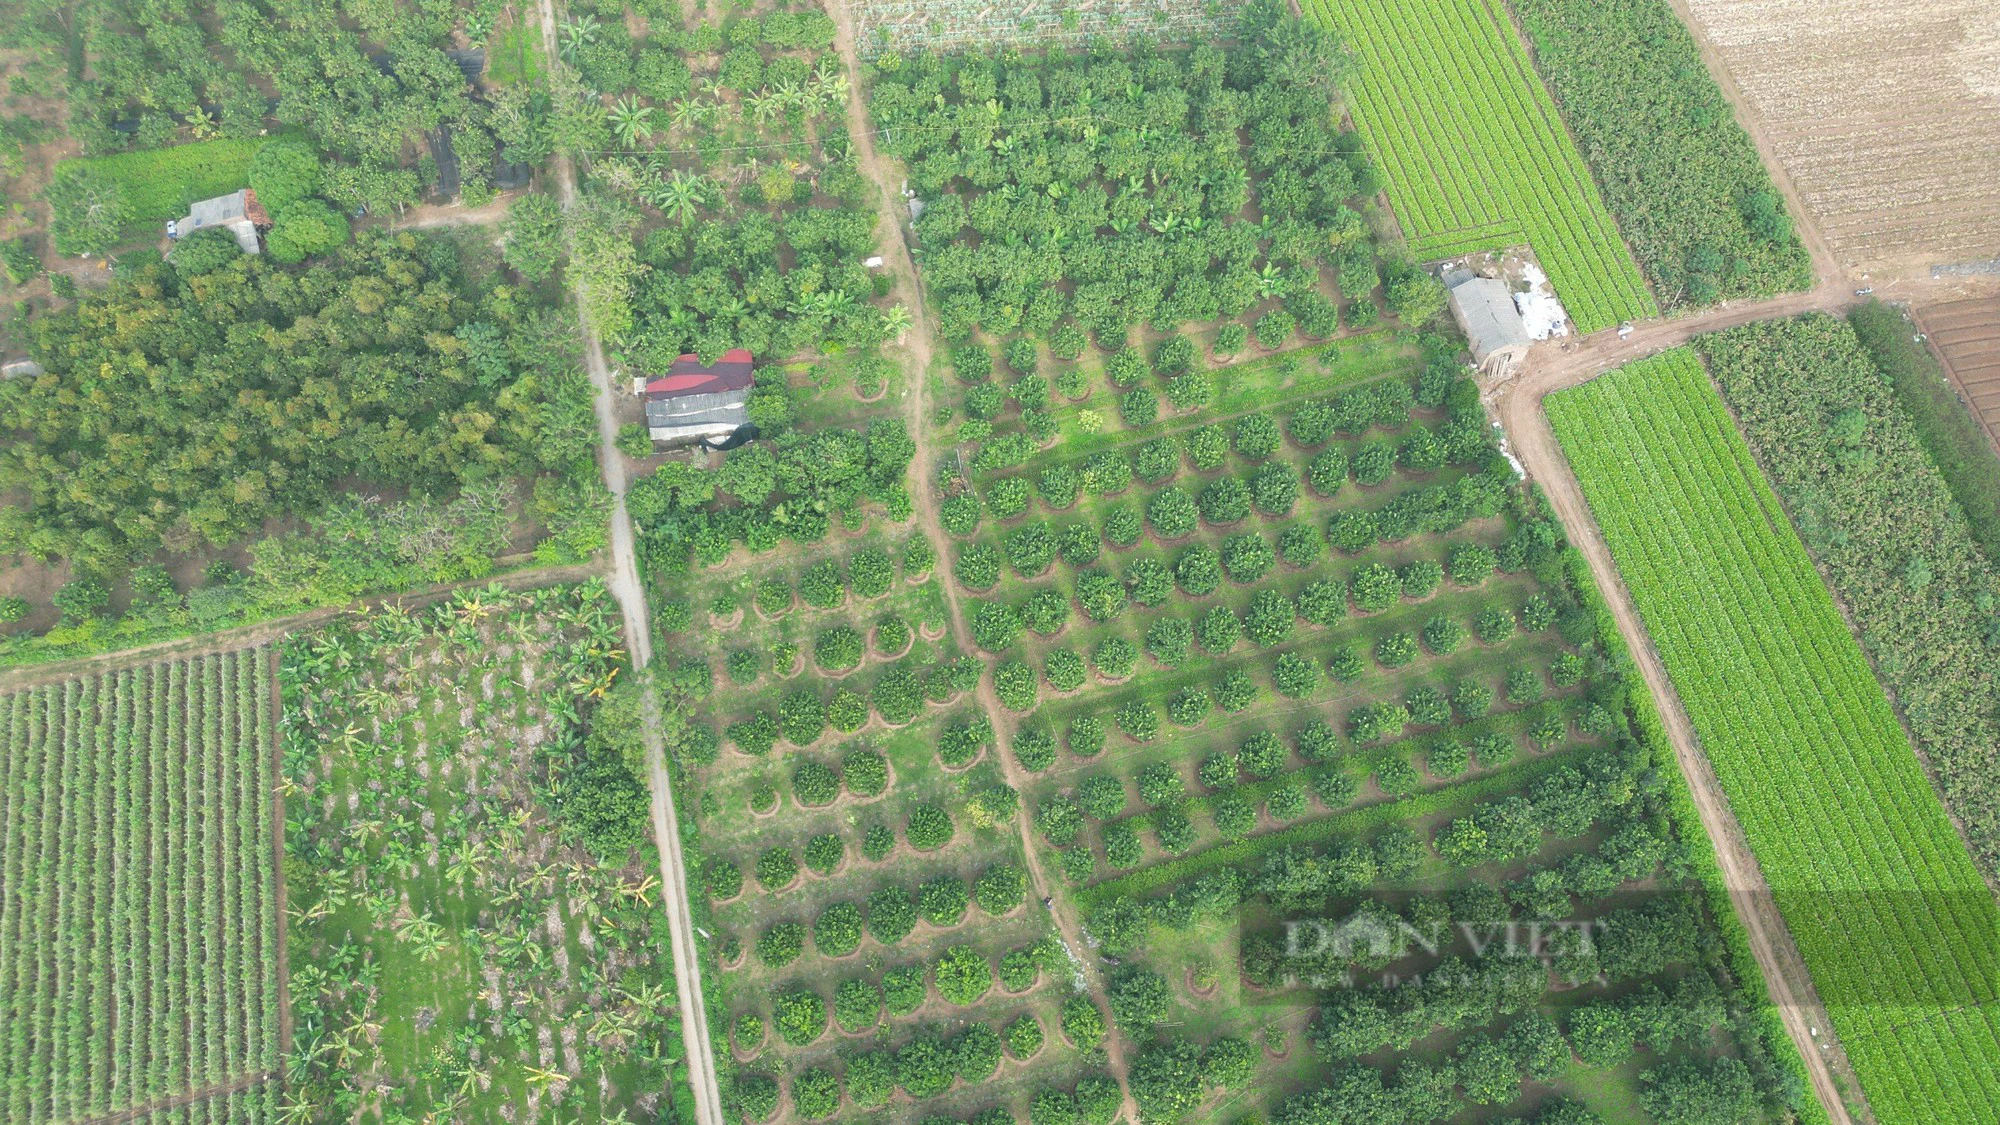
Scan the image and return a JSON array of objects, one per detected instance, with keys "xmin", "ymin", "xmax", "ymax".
[{"xmin": 540, "ymin": 0, "xmax": 726, "ymax": 1125}]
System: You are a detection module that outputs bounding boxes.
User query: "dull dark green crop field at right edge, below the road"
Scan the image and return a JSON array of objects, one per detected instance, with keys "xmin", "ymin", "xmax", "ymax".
[{"xmin": 1696, "ymin": 306, "xmax": 2000, "ymax": 873}]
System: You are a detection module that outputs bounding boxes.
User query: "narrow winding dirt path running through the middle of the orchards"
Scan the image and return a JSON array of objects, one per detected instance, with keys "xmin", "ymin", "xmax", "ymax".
[{"xmin": 820, "ymin": 0, "xmax": 1138, "ymax": 1121}]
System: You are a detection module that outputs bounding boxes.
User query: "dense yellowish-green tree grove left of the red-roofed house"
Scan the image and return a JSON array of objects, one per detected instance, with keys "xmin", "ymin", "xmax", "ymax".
[{"xmin": 0, "ymin": 231, "xmax": 592, "ymax": 571}]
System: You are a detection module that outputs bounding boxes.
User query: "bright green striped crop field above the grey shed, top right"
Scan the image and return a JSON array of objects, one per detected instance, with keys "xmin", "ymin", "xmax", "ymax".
[{"xmin": 1304, "ymin": 0, "xmax": 1658, "ymax": 332}]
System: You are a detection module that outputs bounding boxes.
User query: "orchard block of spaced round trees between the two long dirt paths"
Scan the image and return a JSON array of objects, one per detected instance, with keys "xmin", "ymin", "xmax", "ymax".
[{"xmin": 668, "ymin": 526, "xmax": 1116, "ymax": 1119}]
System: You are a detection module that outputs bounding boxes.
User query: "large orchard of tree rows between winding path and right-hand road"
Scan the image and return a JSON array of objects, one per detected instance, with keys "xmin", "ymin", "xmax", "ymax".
[{"xmin": 942, "ymin": 312, "xmax": 1816, "ymax": 1123}]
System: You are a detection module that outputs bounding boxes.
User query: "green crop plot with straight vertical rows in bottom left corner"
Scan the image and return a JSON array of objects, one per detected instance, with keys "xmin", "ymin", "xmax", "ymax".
[{"xmin": 0, "ymin": 649, "xmax": 278, "ymax": 1125}]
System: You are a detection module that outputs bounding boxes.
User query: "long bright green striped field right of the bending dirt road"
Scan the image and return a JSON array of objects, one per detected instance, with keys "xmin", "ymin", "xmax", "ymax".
[{"xmin": 1548, "ymin": 350, "xmax": 2000, "ymax": 1125}]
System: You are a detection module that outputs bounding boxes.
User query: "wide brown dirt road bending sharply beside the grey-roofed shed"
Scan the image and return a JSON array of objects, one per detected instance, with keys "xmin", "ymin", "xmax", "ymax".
[{"xmin": 1492, "ymin": 296, "xmax": 1872, "ymax": 1125}]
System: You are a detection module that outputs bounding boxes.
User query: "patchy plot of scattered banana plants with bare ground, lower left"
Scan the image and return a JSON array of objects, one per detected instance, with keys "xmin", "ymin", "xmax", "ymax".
[{"xmin": 278, "ymin": 583, "xmax": 694, "ymax": 1125}]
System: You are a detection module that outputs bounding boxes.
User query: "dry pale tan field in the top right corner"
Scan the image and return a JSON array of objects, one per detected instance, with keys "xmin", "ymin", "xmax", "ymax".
[{"xmin": 1686, "ymin": 0, "xmax": 2000, "ymax": 268}]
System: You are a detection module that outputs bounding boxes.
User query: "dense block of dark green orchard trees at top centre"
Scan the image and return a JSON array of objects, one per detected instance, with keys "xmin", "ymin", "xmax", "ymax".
[{"xmin": 870, "ymin": 4, "xmax": 1376, "ymax": 344}]
